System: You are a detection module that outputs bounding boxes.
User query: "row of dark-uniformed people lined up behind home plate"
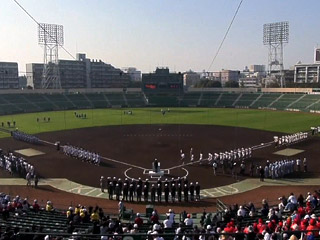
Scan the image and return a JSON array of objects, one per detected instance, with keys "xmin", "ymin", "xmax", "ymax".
[{"xmin": 100, "ymin": 176, "xmax": 200, "ymax": 203}]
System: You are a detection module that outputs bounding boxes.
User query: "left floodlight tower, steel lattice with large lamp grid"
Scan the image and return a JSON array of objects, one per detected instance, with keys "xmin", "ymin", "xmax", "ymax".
[{"xmin": 38, "ymin": 23, "xmax": 64, "ymax": 89}]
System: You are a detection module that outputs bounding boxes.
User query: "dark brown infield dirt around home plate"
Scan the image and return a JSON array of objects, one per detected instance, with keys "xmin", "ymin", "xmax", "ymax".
[{"xmin": 0, "ymin": 124, "xmax": 320, "ymax": 188}]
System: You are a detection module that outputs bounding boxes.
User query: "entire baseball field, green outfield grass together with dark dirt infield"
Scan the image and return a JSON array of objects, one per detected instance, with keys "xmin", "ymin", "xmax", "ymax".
[{"xmin": 0, "ymin": 108, "xmax": 320, "ymax": 212}]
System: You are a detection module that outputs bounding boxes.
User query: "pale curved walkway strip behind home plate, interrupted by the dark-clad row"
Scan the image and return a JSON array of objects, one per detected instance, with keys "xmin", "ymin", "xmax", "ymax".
[{"xmin": 0, "ymin": 178, "xmax": 320, "ymax": 198}]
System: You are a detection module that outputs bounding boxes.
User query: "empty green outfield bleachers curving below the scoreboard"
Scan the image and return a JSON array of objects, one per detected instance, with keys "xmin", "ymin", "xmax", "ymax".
[{"xmin": 0, "ymin": 92, "xmax": 320, "ymax": 115}]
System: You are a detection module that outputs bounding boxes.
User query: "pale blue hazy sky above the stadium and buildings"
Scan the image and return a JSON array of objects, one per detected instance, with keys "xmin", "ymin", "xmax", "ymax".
[{"xmin": 0, "ymin": 0, "xmax": 320, "ymax": 75}]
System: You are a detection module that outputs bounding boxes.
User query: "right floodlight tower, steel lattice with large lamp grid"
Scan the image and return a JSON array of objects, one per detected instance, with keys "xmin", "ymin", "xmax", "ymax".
[{"xmin": 263, "ymin": 22, "xmax": 289, "ymax": 87}]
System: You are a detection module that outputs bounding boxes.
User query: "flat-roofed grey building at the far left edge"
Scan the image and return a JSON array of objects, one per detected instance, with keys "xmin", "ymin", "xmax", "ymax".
[{"xmin": 0, "ymin": 62, "xmax": 19, "ymax": 89}]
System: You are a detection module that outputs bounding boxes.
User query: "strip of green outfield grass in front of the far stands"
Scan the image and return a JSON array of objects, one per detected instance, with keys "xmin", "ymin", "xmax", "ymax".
[{"xmin": 0, "ymin": 108, "xmax": 320, "ymax": 138}]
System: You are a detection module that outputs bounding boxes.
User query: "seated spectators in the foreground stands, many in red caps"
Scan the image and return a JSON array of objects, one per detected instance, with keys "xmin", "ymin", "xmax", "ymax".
[{"xmin": 0, "ymin": 191, "xmax": 320, "ymax": 240}]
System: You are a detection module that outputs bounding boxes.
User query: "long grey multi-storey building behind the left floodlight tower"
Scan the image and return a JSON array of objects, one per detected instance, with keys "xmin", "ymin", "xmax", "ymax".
[{"xmin": 26, "ymin": 53, "xmax": 130, "ymax": 89}]
